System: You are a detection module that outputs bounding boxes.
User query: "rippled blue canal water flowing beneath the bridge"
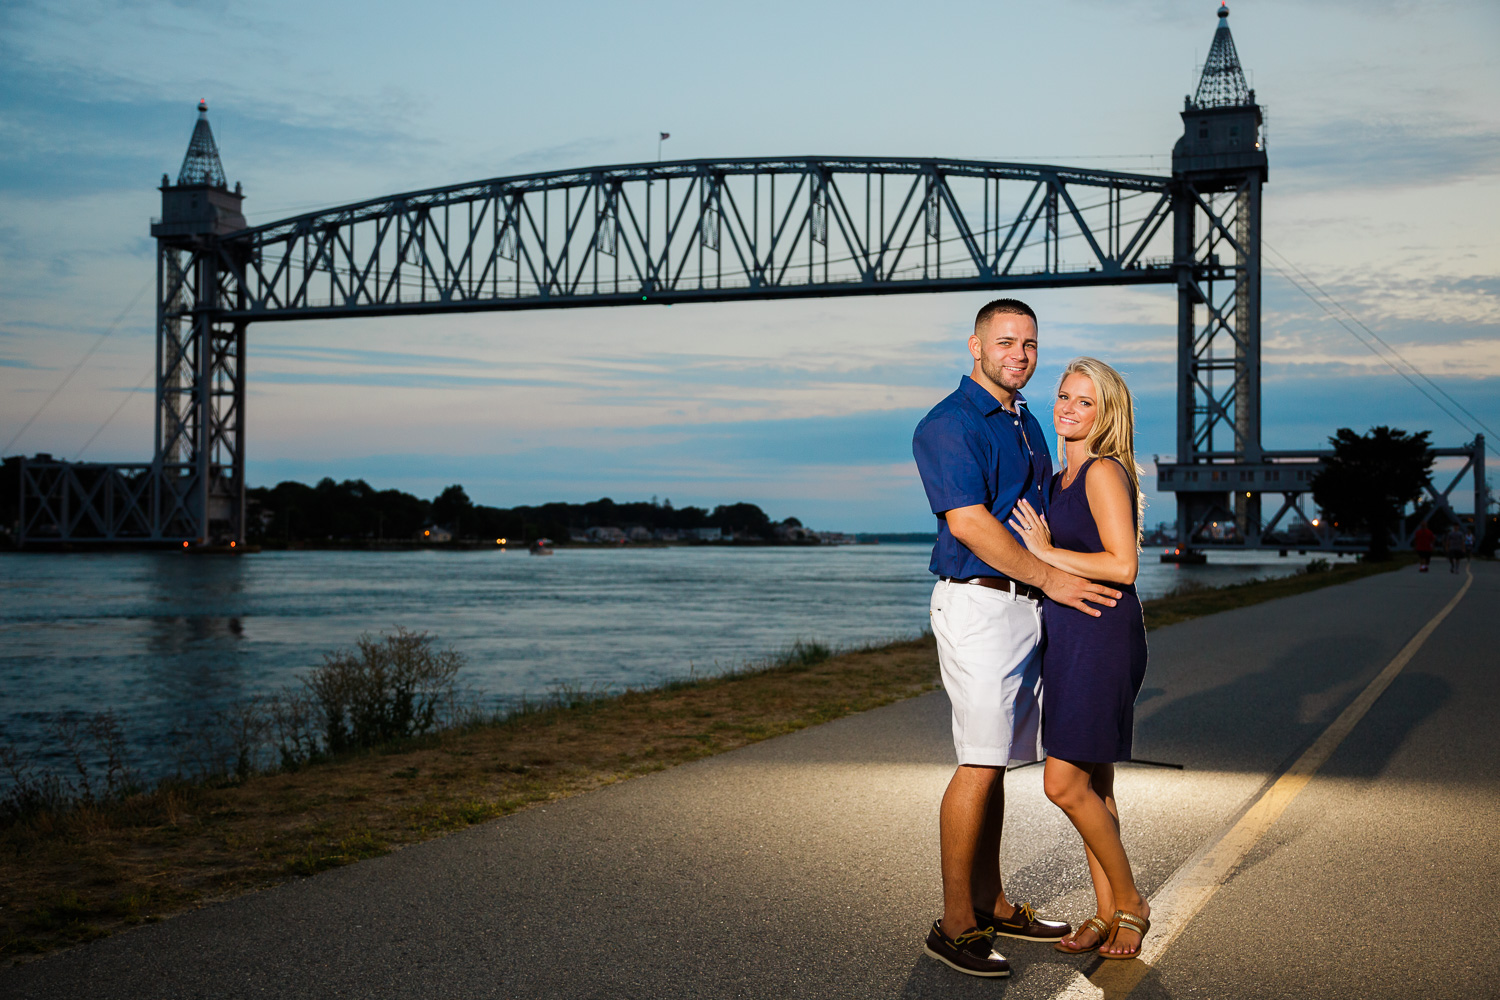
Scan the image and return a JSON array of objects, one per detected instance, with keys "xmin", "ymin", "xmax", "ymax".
[{"xmin": 0, "ymin": 544, "xmax": 1338, "ymax": 783}]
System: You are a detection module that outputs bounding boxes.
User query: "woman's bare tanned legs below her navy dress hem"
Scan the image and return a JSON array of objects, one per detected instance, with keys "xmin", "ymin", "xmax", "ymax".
[{"xmin": 1043, "ymin": 757, "xmax": 1151, "ymax": 954}]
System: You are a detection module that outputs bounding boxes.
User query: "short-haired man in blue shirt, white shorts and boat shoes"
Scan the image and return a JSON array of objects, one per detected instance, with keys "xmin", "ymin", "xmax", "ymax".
[{"xmin": 912, "ymin": 298, "xmax": 1121, "ymax": 978}]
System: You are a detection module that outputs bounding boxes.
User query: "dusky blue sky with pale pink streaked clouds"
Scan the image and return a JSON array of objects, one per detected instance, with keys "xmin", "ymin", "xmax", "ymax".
[{"xmin": 0, "ymin": 0, "xmax": 1500, "ymax": 531}]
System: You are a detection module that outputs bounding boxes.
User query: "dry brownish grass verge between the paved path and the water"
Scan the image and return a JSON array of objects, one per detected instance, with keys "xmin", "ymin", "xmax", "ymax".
[{"xmin": 0, "ymin": 562, "xmax": 1403, "ymax": 958}]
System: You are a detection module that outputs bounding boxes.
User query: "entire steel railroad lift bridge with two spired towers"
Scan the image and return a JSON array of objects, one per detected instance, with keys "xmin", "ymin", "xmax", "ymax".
[{"xmin": 20, "ymin": 7, "xmax": 1484, "ymax": 553}]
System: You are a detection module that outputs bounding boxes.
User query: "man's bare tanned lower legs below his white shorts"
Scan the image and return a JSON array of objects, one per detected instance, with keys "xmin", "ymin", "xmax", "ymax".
[{"xmin": 938, "ymin": 765, "xmax": 1010, "ymax": 937}]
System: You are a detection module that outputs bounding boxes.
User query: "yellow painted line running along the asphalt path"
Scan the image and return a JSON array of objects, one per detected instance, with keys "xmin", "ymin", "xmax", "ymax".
[{"xmin": 1059, "ymin": 568, "xmax": 1475, "ymax": 1000}]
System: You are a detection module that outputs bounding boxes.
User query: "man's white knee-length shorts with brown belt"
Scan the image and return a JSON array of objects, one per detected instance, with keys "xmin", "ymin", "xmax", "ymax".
[{"xmin": 932, "ymin": 580, "xmax": 1043, "ymax": 768}]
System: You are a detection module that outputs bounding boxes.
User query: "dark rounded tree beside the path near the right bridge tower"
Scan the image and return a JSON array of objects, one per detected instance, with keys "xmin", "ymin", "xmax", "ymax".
[{"xmin": 1313, "ymin": 427, "xmax": 1434, "ymax": 559}]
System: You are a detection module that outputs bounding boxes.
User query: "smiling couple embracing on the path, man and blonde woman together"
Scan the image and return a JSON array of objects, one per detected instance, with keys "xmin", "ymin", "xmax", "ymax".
[{"xmin": 912, "ymin": 298, "xmax": 1151, "ymax": 976}]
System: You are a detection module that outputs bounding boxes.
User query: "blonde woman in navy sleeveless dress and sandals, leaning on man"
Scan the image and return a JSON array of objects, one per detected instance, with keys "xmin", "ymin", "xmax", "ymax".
[{"xmin": 1011, "ymin": 358, "xmax": 1151, "ymax": 958}]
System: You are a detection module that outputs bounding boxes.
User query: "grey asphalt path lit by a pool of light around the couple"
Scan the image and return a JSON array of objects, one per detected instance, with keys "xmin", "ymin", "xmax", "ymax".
[{"xmin": 0, "ymin": 564, "xmax": 1500, "ymax": 1000}]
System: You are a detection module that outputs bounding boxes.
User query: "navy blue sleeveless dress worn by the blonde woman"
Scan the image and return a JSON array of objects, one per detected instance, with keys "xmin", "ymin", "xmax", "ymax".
[{"xmin": 1041, "ymin": 459, "xmax": 1146, "ymax": 763}]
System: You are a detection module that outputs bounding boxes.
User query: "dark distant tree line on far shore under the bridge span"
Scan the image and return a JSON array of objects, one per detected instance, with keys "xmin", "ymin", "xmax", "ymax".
[{"xmin": 246, "ymin": 478, "xmax": 801, "ymax": 544}]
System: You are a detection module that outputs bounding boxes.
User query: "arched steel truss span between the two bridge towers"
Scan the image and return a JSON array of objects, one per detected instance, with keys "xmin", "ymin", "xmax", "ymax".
[{"xmin": 214, "ymin": 156, "xmax": 1175, "ymax": 322}]
